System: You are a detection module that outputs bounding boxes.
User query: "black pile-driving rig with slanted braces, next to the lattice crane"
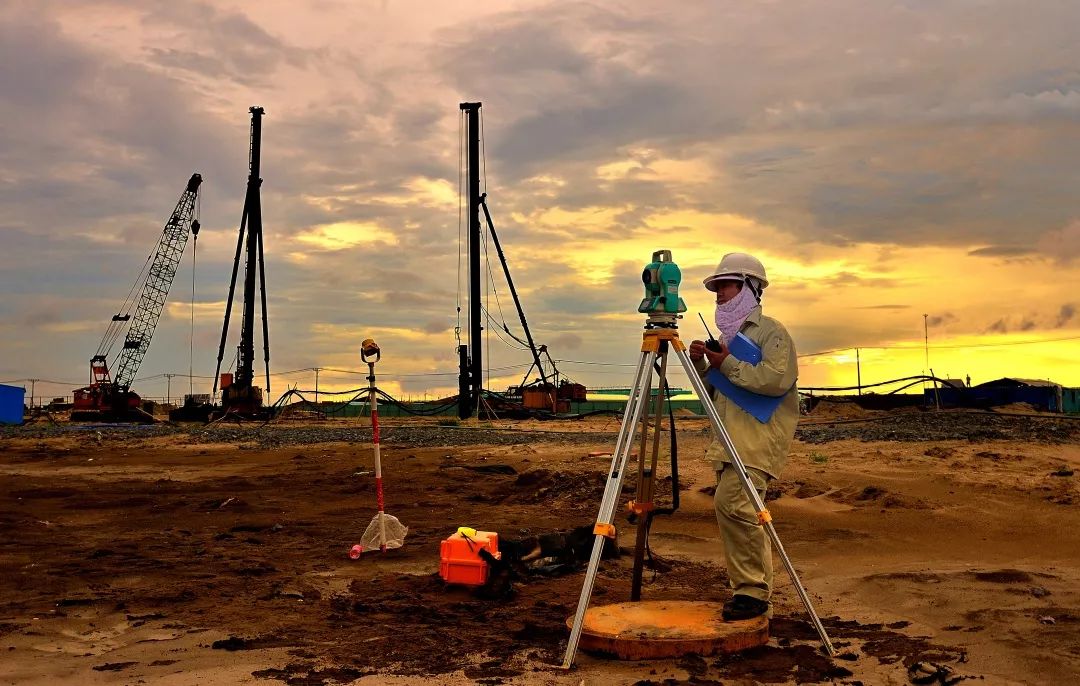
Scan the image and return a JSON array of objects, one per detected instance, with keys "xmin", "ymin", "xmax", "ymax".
[{"xmin": 214, "ymin": 107, "xmax": 270, "ymax": 416}]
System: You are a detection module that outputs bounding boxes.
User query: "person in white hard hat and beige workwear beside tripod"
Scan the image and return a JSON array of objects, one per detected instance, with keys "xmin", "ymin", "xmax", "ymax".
[{"xmin": 689, "ymin": 253, "xmax": 799, "ymax": 621}]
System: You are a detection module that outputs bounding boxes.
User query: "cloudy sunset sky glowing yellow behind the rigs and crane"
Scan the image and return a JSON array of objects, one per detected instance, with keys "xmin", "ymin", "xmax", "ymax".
[{"xmin": 0, "ymin": 0, "xmax": 1080, "ymax": 398}]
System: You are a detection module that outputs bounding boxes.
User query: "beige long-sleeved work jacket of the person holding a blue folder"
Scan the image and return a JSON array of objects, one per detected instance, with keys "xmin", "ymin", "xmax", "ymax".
[{"xmin": 696, "ymin": 306, "xmax": 799, "ymax": 479}]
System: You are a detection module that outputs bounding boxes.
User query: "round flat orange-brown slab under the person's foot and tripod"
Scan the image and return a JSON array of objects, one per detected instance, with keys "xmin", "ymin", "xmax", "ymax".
[{"xmin": 566, "ymin": 601, "xmax": 769, "ymax": 660}]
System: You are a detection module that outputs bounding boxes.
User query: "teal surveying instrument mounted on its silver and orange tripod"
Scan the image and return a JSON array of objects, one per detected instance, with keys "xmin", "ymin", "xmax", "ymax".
[{"xmin": 563, "ymin": 250, "xmax": 836, "ymax": 669}]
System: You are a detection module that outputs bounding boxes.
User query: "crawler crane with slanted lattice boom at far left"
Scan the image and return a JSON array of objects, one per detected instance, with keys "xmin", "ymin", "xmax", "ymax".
[{"xmin": 71, "ymin": 174, "xmax": 202, "ymax": 421}]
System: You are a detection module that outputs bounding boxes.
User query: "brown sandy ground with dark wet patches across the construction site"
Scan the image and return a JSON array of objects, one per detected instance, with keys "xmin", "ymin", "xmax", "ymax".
[{"xmin": 0, "ymin": 408, "xmax": 1080, "ymax": 685}]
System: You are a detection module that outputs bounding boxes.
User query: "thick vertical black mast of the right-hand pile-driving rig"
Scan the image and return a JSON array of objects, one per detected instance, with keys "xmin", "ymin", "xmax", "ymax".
[{"xmin": 458, "ymin": 103, "xmax": 484, "ymax": 419}]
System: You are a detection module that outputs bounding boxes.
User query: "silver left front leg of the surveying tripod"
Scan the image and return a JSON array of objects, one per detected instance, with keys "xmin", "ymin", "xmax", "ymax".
[{"xmin": 563, "ymin": 351, "xmax": 657, "ymax": 670}]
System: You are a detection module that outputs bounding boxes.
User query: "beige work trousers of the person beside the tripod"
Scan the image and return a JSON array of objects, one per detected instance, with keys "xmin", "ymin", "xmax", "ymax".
[{"xmin": 713, "ymin": 463, "xmax": 772, "ymax": 601}]
